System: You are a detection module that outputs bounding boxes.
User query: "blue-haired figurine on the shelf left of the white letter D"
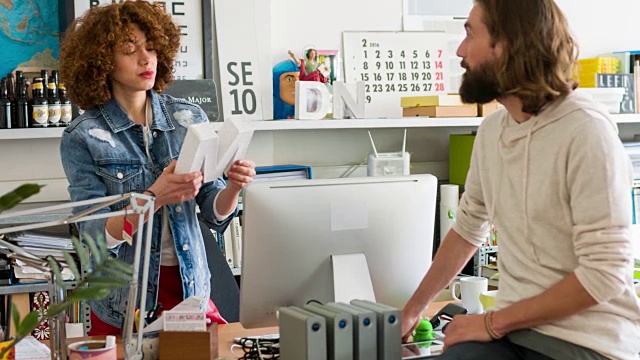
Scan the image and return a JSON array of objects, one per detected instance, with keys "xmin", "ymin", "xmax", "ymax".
[{"xmin": 273, "ymin": 60, "xmax": 300, "ymax": 120}]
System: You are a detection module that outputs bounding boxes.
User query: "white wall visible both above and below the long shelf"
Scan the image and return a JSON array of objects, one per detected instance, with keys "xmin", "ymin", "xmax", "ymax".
[{"xmin": 6, "ymin": 0, "xmax": 640, "ymax": 199}]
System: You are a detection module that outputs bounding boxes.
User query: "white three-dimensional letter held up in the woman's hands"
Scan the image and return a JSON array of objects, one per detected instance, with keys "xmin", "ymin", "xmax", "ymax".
[{"xmin": 175, "ymin": 119, "xmax": 253, "ymax": 182}]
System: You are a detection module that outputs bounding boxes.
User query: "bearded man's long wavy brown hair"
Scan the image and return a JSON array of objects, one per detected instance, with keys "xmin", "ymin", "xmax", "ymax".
[{"xmin": 476, "ymin": 0, "xmax": 578, "ymax": 114}]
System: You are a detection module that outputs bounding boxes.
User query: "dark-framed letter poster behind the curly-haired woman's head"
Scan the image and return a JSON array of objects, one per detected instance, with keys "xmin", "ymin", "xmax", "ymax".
[{"xmin": 58, "ymin": 0, "xmax": 217, "ymax": 80}]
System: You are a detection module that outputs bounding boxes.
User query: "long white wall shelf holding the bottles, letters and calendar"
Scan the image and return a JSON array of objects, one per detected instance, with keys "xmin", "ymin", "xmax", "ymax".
[{"xmin": 0, "ymin": 114, "xmax": 640, "ymax": 140}]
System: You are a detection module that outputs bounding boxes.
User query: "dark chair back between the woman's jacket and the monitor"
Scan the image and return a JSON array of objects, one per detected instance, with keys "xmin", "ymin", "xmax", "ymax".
[{"xmin": 200, "ymin": 221, "xmax": 240, "ymax": 322}]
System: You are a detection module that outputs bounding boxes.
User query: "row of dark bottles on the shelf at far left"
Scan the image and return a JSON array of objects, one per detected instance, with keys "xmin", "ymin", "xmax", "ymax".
[{"xmin": 0, "ymin": 70, "xmax": 72, "ymax": 129}]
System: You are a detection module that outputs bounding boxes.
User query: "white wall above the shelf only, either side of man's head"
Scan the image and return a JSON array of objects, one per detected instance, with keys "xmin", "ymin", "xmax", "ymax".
[{"xmin": 271, "ymin": 0, "xmax": 640, "ymax": 64}]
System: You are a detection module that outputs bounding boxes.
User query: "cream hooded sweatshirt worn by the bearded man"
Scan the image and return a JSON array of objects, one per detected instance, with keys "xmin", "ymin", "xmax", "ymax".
[{"xmin": 453, "ymin": 92, "xmax": 640, "ymax": 359}]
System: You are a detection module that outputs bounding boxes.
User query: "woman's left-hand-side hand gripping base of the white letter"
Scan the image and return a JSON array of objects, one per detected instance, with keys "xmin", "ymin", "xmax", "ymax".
[{"xmin": 149, "ymin": 160, "xmax": 203, "ymax": 208}]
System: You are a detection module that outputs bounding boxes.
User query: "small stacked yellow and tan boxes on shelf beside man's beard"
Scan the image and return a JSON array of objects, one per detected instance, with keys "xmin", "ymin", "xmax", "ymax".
[{"xmin": 400, "ymin": 94, "xmax": 478, "ymax": 117}]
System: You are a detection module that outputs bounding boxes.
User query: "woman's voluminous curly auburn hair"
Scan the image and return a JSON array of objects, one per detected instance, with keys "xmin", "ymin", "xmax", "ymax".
[{"xmin": 60, "ymin": 1, "xmax": 180, "ymax": 110}]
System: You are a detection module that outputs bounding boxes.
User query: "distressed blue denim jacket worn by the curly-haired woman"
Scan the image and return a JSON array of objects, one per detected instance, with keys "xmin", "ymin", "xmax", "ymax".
[{"xmin": 60, "ymin": 90, "xmax": 237, "ymax": 327}]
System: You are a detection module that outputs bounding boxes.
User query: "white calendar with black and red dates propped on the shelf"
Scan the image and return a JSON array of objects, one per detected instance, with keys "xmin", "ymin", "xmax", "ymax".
[{"xmin": 343, "ymin": 32, "xmax": 460, "ymax": 118}]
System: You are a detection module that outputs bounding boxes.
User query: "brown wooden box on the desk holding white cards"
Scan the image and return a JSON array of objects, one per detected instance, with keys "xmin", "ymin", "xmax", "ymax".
[{"xmin": 159, "ymin": 323, "xmax": 218, "ymax": 360}]
